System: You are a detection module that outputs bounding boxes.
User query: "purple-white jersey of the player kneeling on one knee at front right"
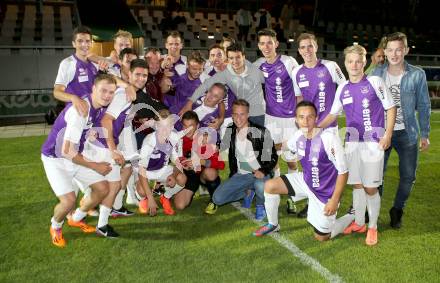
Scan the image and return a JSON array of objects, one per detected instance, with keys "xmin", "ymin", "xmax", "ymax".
[{"xmin": 287, "ymin": 130, "xmax": 348, "ymax": 204}]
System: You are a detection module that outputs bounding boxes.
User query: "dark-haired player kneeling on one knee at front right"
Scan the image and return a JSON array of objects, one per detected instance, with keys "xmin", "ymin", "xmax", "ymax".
[{"xmin": 253, "ymin": 101, "xmax": 353, "ymax": 241}]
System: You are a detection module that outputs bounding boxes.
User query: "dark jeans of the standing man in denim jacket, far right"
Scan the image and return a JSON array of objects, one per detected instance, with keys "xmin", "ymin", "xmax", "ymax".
[{"xmin": 379, "ymin": 130, "xmax": 419, "ymax": 209}]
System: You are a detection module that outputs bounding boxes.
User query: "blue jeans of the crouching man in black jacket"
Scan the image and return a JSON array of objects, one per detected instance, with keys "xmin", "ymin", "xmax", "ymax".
[{"xmin": 212, "ymin": 173, "xmax": 270, "ymax": 205}]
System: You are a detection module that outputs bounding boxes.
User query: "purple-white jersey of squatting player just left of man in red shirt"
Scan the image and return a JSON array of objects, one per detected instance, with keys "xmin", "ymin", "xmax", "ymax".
[{"xmin": 139, "ymin": 132, "xmax": 179, "ymax": 171}]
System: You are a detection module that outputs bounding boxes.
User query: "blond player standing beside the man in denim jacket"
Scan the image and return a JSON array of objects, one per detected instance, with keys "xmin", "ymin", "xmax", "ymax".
[{"xmin": 319, "ymin": 45, "xmax": 396, "ymax": 246}]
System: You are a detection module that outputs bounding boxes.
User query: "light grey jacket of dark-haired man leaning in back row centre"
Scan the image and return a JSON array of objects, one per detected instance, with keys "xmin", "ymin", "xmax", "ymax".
[{"xmin": 190, "ymin": 62, "xmax": 266, "ymax": 116}]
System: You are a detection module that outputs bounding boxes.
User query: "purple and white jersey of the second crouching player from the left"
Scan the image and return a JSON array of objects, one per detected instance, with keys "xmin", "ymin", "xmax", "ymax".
[{"xmin": 92, "ymin": 88, "xmax": 132, "ymax": 148}]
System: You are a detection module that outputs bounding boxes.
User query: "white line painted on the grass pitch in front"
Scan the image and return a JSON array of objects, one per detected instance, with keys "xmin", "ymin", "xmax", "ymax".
[{"xmin": 231, "ymin": 202, "xmax": 344, "ymax": 282}]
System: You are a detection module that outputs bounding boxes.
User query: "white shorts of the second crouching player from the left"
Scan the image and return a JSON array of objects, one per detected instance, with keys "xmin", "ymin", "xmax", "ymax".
[{"xmin": 82, "ymin": 141, "xmax": 121, "ymax": 182}]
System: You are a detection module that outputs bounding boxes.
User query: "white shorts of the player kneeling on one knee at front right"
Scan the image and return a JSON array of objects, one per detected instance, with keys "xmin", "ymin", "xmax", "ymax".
[{"xmin": 281, "ymin": 172, "xmax": 336, "ymax": 234}]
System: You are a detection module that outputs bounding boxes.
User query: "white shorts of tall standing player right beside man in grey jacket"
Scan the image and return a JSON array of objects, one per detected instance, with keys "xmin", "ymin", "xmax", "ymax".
[{"xmin": 264, "ymin": 114, "xmax": 298, "ymax": 144}]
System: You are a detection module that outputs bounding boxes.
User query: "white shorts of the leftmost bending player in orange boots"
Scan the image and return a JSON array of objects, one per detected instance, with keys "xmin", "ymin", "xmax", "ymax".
[{"xmin": 41, "ymin": 155, "xmax": 105, "ymax": 196}]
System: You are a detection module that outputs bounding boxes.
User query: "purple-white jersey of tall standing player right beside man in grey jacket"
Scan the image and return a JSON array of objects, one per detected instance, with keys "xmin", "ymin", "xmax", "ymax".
[{"xmin": 254, "ymin": 55, "xmax": 298, "ymax": 118}]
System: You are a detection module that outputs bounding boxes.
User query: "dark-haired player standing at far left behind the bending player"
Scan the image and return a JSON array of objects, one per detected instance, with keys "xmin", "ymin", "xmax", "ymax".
[{"xmin": 53, "ymin": 26, "xmax": 98, "ymax": 115}]
